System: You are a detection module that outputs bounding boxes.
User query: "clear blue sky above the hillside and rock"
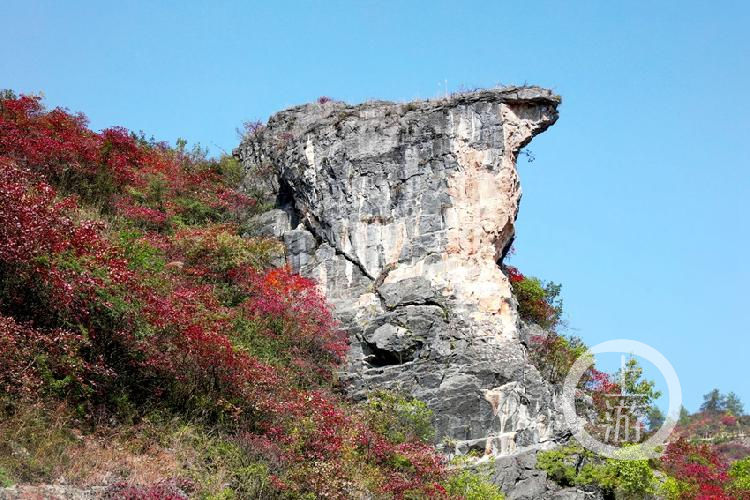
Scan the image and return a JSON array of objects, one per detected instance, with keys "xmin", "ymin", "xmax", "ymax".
[{"xmin": 0, "ymin": 0, "xmax": 750, "ymax": 410}]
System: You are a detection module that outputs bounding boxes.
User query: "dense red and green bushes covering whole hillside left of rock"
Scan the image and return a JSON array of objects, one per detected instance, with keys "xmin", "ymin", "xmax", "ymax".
[{"xmin": 0, "ymin": 93, "xmax": 506, "ymax": 498}]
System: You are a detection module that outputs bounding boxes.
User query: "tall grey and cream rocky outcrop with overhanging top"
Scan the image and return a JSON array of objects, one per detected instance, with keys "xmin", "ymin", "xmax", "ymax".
[{"xmin": 235, "ymin": 87, "xmax": 592, "ymax": 498}]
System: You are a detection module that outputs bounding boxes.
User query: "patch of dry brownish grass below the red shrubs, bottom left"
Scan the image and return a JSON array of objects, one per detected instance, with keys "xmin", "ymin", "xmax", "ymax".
[{"xmin": 0, "ymin": 403, "xmax": 272, "ymax": 498}]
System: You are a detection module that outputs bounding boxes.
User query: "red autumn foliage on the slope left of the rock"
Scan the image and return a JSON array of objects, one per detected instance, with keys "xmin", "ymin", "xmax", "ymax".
[{"xmin": 0, "ymin": 93, "xmax": 452, "ymax": 498}]
